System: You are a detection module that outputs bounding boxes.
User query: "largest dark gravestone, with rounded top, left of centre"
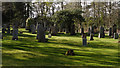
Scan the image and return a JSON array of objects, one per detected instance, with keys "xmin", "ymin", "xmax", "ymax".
[{"xmin": 37, "ymin": 24, "xmax": 46, "ymax": 42}]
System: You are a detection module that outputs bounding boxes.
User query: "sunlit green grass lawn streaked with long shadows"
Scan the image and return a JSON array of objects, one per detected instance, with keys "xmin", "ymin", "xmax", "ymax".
[{"xmin": 2, "ymin": 29, "xmax": 119, "ymax": 66}]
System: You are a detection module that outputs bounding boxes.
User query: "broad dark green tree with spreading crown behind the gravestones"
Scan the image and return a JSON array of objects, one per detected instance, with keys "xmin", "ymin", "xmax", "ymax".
[{"xmin": 53, "ymin": 9, "xmax": 85, "ymax": 35}]
